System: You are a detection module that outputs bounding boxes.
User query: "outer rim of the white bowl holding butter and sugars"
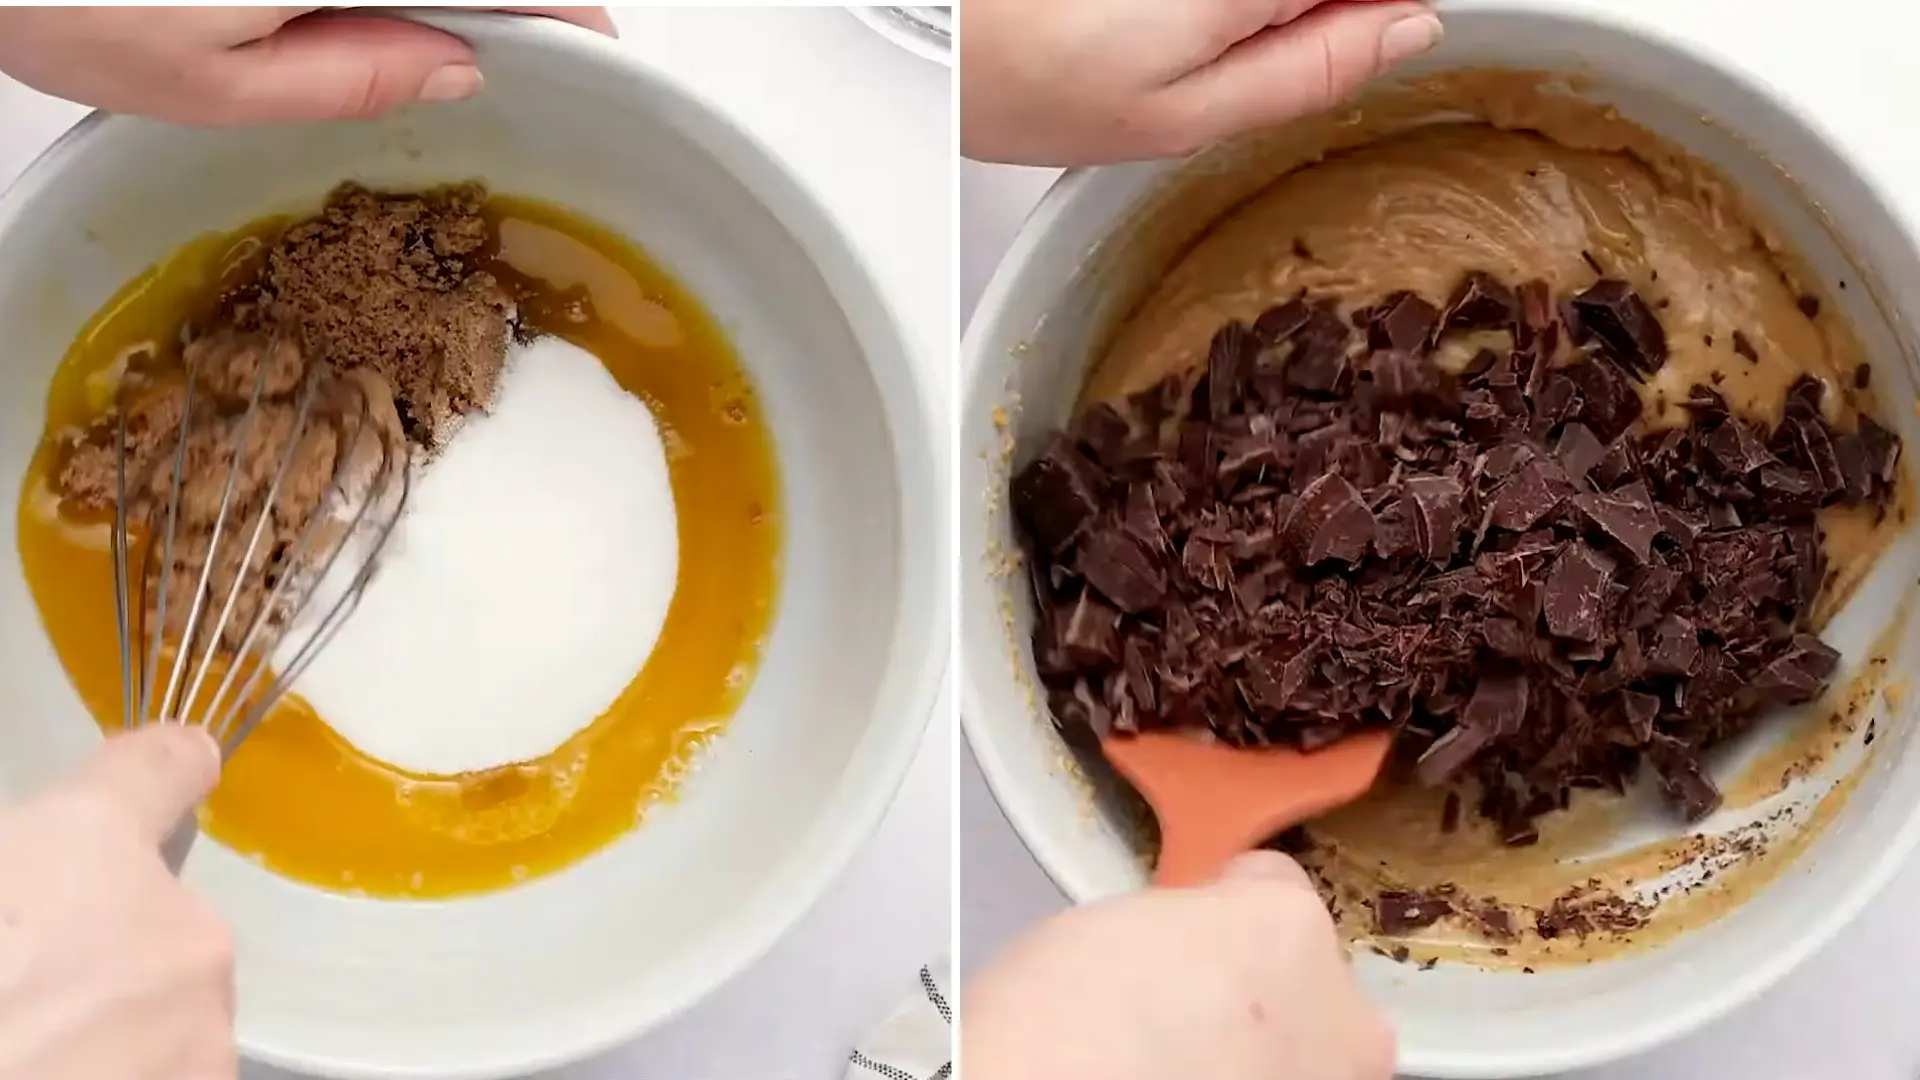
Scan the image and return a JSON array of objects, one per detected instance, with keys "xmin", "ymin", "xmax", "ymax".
[{"xmin": 0, "ymin": 8, "xmax": 952, "ymax": 1080}]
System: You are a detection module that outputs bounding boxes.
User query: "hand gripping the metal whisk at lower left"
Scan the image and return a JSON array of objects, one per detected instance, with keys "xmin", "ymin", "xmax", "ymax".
[{"xmin": 0, "ymin": 724, "xmax": 240, "ymax": 1080}]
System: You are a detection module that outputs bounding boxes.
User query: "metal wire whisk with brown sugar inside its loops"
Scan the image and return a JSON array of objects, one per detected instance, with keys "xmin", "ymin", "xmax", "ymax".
[{"xmin": 111, "ymin": 349, "xmax": 411, "ymax": 872}]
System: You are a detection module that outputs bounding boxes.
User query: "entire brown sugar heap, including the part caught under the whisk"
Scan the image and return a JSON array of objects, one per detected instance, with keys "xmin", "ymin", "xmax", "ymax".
[{"xmin": 56, "ymin": 184, "xmax": 515, "ymax": 648}]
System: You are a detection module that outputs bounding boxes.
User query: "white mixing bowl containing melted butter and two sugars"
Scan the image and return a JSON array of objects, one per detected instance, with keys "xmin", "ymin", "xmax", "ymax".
[{"xmin": 0, "ymin": 15, "xmax": 950, "ymax": 1078}]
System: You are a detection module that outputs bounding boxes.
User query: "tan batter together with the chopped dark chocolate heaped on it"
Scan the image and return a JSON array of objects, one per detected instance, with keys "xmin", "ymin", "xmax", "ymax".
[{"xmin": 1012, "ymin": 73, "xmax": 1908, "ymax": 965}]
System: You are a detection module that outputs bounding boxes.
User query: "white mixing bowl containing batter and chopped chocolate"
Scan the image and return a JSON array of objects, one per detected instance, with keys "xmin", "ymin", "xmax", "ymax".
[{"xmin": 958, "ymin": 0, "xmax": 1920, "ymax": 1078}]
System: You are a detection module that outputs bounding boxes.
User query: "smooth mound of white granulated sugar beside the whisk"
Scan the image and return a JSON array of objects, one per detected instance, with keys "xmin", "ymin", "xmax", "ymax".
[{"xmin": 276, "ymin": 338, "xmax": 680, "ymax": 776}]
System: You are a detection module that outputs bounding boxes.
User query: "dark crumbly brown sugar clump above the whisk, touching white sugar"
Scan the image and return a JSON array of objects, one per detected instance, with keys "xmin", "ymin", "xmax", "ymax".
[{"xmin": 228, "ymin": 184, "xmax": 515, "ymax": 450}]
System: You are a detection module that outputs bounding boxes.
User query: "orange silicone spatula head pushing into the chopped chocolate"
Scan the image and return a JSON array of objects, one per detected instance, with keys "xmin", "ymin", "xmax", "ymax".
[{"xmin": 1100, "ymin": 732, "xmax": 1392, "ymax": 886}]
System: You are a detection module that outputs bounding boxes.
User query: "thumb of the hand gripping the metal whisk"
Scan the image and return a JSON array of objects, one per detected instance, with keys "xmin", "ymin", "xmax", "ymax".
[{"xmin": 67, "ymin": 724, "xmax": 221, "ymax": 847}]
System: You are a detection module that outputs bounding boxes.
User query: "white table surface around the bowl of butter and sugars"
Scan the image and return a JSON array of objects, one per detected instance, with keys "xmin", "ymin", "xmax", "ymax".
[{"xmin": 0, "ymin": 8, "xmax": 954, "ymax": 1080}]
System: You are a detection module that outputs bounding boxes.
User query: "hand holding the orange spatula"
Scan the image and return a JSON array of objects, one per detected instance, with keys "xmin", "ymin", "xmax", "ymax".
[{"xmin": 960, "ymin": 851, "xmax": 1394, "ymax": 1080}]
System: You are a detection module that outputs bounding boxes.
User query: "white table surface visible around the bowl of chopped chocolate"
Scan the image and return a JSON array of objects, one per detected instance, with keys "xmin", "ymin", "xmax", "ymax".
[{"xmin": 960, "ymin": 0, "xmax": 1920, "ymax": 1080}]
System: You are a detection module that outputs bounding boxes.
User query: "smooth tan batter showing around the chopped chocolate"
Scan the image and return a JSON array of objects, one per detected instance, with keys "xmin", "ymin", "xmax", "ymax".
[{"xmin": 1090, "ymin": 71, "xmax": 1914, "ymax": 967}]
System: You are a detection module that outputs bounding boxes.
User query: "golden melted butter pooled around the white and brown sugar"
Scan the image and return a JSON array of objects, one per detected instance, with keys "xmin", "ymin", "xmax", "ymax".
[{"xmin": 17, "ymin": 196, "xmax": 780, "ymax": 897}]
